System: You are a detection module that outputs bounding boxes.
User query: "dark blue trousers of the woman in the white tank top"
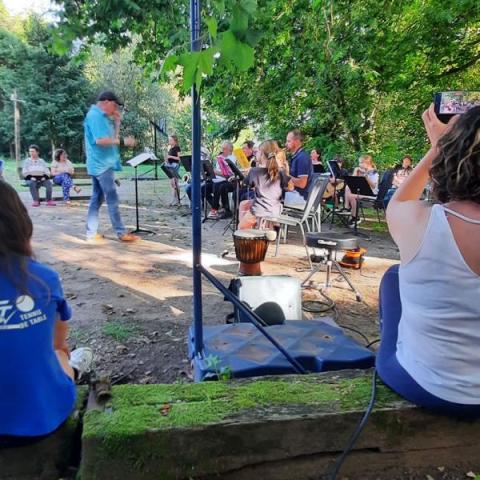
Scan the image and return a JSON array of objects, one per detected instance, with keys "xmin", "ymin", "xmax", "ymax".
[{"xmin": 376, "ymin": 265, "xmax": 480, "ymax": 417}]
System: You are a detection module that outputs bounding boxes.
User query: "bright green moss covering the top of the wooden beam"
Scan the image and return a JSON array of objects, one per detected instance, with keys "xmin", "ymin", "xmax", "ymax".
[{"xmin": 83, "ymin": 375, "xmax": 399, "ymax": 438}]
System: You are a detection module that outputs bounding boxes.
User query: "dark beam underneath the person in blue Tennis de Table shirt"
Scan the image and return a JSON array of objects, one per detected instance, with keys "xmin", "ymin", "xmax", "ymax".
[{"xmin": 0, "ymin": 387, "xmax": 88, "ymax": 480}]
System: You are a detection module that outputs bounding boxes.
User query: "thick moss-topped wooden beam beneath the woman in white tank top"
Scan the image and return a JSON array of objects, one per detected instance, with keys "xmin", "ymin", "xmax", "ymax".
[{"xmin": 81, "ymin": 371, "xmax": 480, "ymax": 480}]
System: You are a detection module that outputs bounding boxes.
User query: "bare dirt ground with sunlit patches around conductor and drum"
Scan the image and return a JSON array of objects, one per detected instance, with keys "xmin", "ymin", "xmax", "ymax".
[{"xmin": 21, "ymin": 180, "xmax": 398, "ymax": 383}]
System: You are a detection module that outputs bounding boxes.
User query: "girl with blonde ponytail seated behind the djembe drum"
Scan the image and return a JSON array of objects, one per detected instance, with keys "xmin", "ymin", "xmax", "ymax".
[{"xmin": 238, "ymin": 140, "xmax": 293, "ymax": 230}]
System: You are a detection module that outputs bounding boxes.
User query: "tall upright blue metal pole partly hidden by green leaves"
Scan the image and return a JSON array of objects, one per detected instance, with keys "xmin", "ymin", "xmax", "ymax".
[{"xmin": 190, "ymin": 0, "xmax": 203, "ymax": 356}]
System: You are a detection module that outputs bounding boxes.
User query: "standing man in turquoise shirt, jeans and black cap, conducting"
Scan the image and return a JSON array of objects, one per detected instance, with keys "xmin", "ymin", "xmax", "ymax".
[{"xmin": 84, "ymin": 92, "xmax": 138, "ymax": 242}]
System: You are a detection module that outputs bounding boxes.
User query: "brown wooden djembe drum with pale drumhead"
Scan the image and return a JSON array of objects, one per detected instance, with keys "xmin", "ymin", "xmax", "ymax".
[{"xmin": 233, "ymin": 229, "xmax": 275, "ymax": 275}]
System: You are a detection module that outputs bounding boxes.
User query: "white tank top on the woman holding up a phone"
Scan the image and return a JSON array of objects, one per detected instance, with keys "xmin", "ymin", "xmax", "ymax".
[{"xmin": 397, "ymin": 205, "xmax": 480, "ymax": 405}]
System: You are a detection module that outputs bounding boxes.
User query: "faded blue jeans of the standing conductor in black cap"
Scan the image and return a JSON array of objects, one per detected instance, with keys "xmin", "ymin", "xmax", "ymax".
[{"xmin": 87, "ymin": 169, "xmax": 125, "ymax": 238}]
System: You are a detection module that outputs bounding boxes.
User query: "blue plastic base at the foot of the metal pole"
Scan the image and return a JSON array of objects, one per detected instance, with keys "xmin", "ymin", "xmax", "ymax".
[{"xmin": 188, "ymin": 320, "xmax": 375, "ymax": 381}]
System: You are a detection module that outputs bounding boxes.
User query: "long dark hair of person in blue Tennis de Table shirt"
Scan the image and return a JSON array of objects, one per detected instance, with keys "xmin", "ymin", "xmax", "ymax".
[{"xmin": 0, "ymin": 180, "xmax": 33, "ymax": 293}]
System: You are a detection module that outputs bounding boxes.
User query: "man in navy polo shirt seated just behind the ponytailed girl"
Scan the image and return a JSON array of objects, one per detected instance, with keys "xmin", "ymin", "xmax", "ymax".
[{"xmin": 285, "ymin": 130, "xmax": 313, "ymax": 206}]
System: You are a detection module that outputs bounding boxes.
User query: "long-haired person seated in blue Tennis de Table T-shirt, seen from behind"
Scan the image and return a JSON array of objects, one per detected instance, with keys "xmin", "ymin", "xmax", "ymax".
[{"xmin": 0, "ymin": 181, "xmax": 93, "ymax": 449}]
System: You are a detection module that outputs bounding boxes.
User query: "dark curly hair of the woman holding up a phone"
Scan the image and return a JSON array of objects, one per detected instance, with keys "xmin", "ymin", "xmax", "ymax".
[{"xmin": 430, "ymin": 106, "xmax": 480, "ymax": 204}]
